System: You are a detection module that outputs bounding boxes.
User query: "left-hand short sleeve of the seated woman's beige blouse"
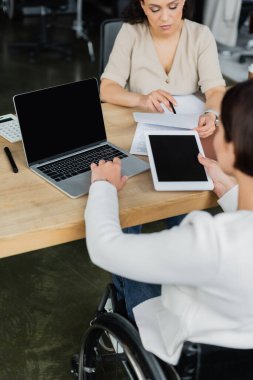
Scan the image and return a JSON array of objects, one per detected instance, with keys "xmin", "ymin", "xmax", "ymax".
[{"xmin": 101, "ymin": 23, "xmax": 135, "ymax": 87}]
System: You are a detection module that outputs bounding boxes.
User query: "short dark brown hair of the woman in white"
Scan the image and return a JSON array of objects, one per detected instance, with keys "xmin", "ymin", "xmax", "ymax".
[{"xmin": 221, "ymin": 79, "xmax": 253, "ymax": 176}]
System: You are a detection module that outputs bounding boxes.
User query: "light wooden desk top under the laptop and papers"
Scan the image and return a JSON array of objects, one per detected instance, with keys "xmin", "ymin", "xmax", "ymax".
[{"xmin": 0, "ymin": 104, "xmax": 216, "ymax": 257}]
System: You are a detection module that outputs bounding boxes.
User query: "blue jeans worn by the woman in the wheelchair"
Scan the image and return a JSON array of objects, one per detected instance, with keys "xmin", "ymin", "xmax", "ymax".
[{"xmin": 112, "ymin": 214, "xmax": 185, "ymax": 321}]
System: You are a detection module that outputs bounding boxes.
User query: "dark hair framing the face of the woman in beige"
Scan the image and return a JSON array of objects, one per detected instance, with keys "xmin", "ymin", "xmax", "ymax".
[{"xmin": 121, "ymin": 0, "xmax": 193, "ymax": 24}]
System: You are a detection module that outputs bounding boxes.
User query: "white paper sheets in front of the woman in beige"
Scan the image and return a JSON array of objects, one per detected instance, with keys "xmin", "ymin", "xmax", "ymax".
[{"xmin": 130, "ymin": 95, "xmax": 205, "ymax": 155}]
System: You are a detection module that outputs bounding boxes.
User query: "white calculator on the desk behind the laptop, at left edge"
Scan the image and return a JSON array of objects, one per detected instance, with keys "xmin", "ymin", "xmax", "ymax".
[{"xmin": 0, "ymin": 113, "xmax": 22, "ymax": 142}]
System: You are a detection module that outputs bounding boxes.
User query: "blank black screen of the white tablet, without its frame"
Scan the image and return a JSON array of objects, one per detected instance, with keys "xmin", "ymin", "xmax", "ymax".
[{"xmin": 149, "ymin": 135, "xmax": 207, "ymax": 182}]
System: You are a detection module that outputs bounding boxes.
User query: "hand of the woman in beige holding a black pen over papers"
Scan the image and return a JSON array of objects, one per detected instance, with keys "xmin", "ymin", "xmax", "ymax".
[{"xmin": 139, "ymin": 90, "xmax": 177, "ymax": 112}]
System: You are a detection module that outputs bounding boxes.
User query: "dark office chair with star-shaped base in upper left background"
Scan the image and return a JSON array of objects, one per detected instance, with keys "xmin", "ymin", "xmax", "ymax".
[{"xmin": 9, "ymin": 0, "xmax": 72, "ymax": 62}]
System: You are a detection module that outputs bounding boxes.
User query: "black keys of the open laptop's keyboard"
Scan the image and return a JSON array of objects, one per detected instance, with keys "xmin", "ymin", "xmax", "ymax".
[{"xmin": 38, "ymin": 145, "xmax": 127, "ymax": 182}]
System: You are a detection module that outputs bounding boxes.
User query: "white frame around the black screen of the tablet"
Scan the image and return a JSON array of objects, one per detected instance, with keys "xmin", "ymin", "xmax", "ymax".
[{"xmin": 145, "ymin": 130, "xmax": 214, "ymax": 191}]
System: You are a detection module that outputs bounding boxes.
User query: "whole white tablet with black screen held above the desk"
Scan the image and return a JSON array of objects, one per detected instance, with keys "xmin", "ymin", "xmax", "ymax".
[{"xmin": 145, "ymin": 130, "xmax": 213, "ymax": 191}]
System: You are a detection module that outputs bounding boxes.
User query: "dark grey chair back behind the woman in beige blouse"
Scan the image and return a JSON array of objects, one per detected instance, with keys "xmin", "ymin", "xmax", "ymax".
[{"xmin": 99, "ymin": 18, "xmax": 123, "ymax": 75}]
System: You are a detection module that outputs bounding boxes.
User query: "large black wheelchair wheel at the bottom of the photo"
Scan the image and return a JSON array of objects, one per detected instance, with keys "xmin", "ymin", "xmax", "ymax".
[{"xmin": 78, "ymin": 313, "xmax": 179, "ymax": 380}]
